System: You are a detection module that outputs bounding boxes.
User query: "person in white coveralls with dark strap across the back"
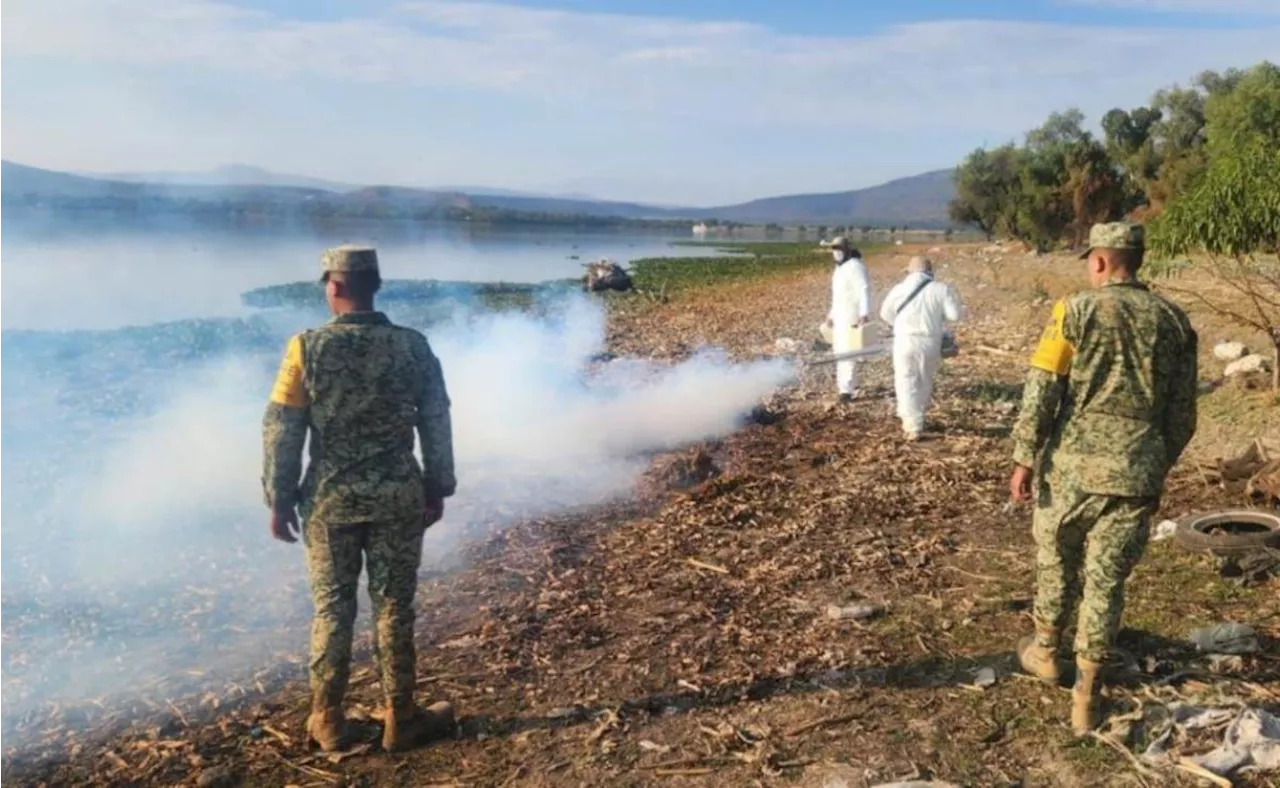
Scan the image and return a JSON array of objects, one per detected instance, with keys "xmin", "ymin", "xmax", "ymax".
[{"xmin": 881, "ymin": 257, "xmax": 964, "ymax": 441}]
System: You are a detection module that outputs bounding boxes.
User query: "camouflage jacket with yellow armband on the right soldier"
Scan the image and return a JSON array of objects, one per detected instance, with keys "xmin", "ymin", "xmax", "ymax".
[{"xmin": 1014, "ymin": 281, "xmax": 1197, "ymax": 496}]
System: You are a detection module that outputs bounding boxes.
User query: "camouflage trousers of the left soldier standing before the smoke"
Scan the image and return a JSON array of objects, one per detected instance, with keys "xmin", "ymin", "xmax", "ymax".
[{"xmin": 305, "ymin": 518, "xmax": 425, "ymax": 706}]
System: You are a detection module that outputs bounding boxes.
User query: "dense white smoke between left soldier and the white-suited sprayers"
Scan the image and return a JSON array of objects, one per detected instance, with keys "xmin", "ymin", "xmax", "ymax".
[{"xmin": 429, "ymin": 299, "xmax": 791, "ymax": 549}]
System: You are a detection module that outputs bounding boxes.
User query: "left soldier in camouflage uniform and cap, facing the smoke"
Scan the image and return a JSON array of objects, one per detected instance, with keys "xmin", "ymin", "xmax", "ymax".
[{"xmin": 262, "ymin": 247, "xmax": 457, "ymax": 751}]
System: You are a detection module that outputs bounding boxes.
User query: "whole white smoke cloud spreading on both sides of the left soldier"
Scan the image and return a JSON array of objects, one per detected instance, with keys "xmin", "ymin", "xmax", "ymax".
[{"xmin": 0, "ymin": 297, "xmax": 792, "ymax": 738}]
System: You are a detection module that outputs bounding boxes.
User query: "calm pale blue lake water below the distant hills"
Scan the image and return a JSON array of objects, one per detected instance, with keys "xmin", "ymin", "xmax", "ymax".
[{"xmin": 0, "ymin": 217, "xmax": 710, "ymax": 330}]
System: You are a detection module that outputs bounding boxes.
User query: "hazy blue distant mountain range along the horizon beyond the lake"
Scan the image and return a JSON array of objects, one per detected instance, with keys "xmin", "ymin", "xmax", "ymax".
[{"xmin": 0, "ymin": 161, "xmax": 955, "ymax": 228}]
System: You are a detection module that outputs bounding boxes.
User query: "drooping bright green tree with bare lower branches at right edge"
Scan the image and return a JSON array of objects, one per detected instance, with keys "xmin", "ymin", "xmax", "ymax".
[{"xmin": 1151, "ymin": 141, "xmax": 1280, "ymax": 389}]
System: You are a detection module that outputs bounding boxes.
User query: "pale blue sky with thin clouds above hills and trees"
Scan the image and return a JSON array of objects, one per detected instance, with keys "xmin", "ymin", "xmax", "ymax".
[{"xmin": 0, "ymin": 0, "xmax": 1280, "ymax": 206}]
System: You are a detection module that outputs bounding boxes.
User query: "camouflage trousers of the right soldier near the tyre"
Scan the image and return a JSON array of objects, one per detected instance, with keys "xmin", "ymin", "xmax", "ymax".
[{"xmin": 1033, "ymin": 486, "xmax": 1158, "ymax": 661}]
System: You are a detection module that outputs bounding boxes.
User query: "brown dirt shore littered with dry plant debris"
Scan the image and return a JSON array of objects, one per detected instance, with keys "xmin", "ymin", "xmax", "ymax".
[{"xmin": 0, "ymin": 246, "xmax": 1280, "ymax": 788}]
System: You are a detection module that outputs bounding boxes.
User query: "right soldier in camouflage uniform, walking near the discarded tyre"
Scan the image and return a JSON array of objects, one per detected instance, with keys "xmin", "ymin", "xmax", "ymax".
[{"xmin": 1011, "ymin": 223, "xmax": 1197, "ymax": 734}]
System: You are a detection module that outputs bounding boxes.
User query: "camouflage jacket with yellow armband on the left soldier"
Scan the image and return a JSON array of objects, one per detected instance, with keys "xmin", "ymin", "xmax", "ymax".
[{"xmin": 262, "ymin": 312, "xmax": 457, "ymax": 524}]
